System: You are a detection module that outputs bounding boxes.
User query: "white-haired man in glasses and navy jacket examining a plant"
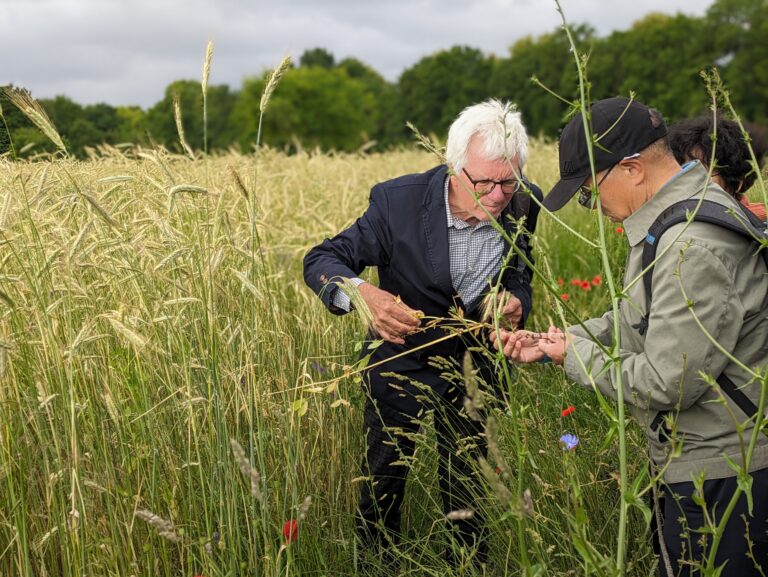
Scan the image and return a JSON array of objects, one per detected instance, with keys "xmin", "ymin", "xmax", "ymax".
[{"xmin": 304, "ymin": 100, "xmax": 542, "ymax": 562}]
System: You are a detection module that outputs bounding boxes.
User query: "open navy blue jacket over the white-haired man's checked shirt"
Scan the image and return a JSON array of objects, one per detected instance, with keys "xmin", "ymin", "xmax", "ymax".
[{"xmin": 304, "ymin": 165, "xmax": 542, "ymax": 415}]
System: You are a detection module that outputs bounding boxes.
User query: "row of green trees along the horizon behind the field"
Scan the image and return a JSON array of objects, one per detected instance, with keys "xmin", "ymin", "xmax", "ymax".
[{"xmin": 0, "ymin": 0, "xmax": 768, "ymax": 157}]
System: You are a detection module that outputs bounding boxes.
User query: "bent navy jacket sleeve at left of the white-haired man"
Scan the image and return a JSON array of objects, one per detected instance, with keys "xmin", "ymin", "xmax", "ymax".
[{"xmin": 304, "ymin": 185, "xmax": 391, "ymax": 315}]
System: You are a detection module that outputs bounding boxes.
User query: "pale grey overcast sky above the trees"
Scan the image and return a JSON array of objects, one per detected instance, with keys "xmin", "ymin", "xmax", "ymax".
[{"xmin": 0, "ymin": 0, "xmax": 712, "ymax": 108}]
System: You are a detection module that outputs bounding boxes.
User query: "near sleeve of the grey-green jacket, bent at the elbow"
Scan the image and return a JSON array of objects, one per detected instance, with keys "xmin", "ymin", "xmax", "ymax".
[{"xmin": 564, "ymin": 241, "xmax": 744, "ymax": 411}]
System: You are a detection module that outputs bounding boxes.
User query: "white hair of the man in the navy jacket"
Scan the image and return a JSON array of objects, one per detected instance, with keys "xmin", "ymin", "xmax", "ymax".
[{"xmin": 445, "ymin": 98, "xmax": 528, "ymax": 172}]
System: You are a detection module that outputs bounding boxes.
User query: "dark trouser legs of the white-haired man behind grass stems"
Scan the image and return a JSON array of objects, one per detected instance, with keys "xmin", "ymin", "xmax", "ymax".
[{"xmin": 358, "ymin": 394, "xmax": 487, "ymax": 562}]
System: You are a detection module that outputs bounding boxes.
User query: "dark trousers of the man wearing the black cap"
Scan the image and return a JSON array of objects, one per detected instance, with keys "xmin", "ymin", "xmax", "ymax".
[{"xmin": 654, "ymin": 469, "xmax": 768, "ymax": 577}]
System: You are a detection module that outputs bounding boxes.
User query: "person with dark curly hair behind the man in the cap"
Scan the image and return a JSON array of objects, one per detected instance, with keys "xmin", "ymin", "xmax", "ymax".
[{"xmin": 669, "ymin": 115, "xmax": 768, "ymax": 220}]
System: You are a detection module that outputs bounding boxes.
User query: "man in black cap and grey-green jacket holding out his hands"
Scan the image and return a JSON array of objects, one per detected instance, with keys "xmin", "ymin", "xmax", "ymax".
[{"xmin": 492, "ymin": 98, "xmax": 768, "ymax": 577}]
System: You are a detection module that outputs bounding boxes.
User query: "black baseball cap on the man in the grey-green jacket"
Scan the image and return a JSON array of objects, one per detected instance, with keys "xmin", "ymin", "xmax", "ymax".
[{"xmin": 544, "ymin": 96, "xmax": 667, "ymax": 211}]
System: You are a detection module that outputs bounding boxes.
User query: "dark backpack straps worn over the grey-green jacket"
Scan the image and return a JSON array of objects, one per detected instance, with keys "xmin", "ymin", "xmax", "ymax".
[{"xmin": 632, "ymin": 198, "xmax": 768, "ymax": 428}]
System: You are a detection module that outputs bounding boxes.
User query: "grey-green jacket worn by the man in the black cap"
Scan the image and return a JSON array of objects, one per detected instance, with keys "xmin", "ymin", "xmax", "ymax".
[{"xmin": 564, "ymin": 162, "xmax": 768, "ymax": 483}]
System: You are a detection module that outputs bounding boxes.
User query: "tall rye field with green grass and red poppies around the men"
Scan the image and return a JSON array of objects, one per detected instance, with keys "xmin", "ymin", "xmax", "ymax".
[{"xmin": 0, "ymin": 142, "xmax": 654, "ymax": 577}]
